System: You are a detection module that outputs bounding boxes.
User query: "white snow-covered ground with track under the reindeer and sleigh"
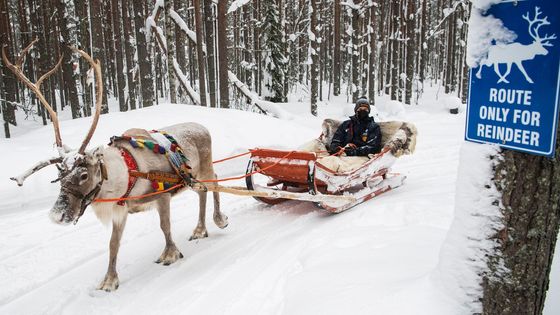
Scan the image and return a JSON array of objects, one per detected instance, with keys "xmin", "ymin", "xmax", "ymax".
[{"xmin": 0, "ymin": 92, "xmax": 560, "ymax": 315}]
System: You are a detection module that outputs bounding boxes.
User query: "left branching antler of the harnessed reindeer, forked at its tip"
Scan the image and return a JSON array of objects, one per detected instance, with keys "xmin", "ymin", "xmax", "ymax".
[{"xmin": 2, "ymin": 38, "xmax": 64, "ymax": 152}]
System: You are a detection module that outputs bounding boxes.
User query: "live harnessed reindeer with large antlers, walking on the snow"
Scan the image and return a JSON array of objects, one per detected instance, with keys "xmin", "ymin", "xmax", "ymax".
[{"xmin": 2, "ymin": 39, "xmax": 228, "ymax": 291}]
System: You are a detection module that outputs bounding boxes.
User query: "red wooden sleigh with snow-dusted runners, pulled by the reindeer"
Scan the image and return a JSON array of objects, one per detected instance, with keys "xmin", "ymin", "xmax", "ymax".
[{"xmin": 232, "ymin": 122, "xmax": 416, "ymax": 213}]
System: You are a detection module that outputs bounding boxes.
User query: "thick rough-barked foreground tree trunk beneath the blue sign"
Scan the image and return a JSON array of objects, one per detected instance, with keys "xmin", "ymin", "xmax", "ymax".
[{"xmin": 482, "ymin": 143, "xmax": 560, "ymax": 315}]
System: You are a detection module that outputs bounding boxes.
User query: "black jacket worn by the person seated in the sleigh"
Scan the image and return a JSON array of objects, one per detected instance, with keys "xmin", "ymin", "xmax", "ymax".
[{"xmin": 329, "ymin": 116, "xmax": 381, "ymax": 156}]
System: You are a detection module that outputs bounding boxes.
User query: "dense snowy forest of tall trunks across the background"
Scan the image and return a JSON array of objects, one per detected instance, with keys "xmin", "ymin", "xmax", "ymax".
[{"xmin": 0, "ymin": 0, "xmax": 471, "ymax": 138}]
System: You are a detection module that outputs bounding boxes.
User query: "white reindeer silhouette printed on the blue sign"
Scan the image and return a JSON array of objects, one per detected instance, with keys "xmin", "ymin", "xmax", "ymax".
[{"xmin": 476, "ymin": 7, "xmax": 556, "ymax": 84}]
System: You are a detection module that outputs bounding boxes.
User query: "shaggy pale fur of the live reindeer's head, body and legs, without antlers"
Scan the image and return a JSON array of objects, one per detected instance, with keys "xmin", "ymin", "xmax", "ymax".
[{"xmin": 50, "ymin": 123, "xmax": 228, "ymax": 291}]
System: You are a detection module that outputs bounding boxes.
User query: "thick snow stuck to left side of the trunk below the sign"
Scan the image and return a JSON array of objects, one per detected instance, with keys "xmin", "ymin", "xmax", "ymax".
[{"xmin": 438, "ymin": 142, "xmax": 502, "ymax": 314}]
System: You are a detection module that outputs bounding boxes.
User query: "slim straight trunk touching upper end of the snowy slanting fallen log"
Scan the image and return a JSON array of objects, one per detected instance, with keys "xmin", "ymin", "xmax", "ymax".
[{"xmin": 218, "ymin": 0, "xmax": 229, "ymax": 108}]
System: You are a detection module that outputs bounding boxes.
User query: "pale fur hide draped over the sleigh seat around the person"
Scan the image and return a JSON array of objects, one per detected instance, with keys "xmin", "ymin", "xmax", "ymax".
[{"xmin": 298, "ymin": 119, "xmax": 418, "ymax": 173}]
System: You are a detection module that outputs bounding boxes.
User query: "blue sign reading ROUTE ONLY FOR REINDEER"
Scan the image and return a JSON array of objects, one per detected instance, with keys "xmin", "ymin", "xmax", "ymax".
[{"xmin": 465, "ymin": 0, "xmax": 560, "ymax": 157}]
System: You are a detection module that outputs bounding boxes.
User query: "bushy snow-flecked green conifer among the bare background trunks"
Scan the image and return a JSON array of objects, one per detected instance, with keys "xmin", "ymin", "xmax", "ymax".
[{"xmin": 262, "ymin": 1, "xmax": 287, "ymax": 102}]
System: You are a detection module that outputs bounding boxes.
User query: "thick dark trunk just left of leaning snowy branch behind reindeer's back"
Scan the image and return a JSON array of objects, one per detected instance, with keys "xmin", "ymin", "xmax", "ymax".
[{"xmin": 133, "ymin": 0, "xmax": 154, "ymax": 107}]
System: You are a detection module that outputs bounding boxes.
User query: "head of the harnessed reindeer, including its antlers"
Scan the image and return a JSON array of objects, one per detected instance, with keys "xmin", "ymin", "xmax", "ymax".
[{"xmin": 2, "ymin": 39, "xmax": 103, "ymax": 224}]
